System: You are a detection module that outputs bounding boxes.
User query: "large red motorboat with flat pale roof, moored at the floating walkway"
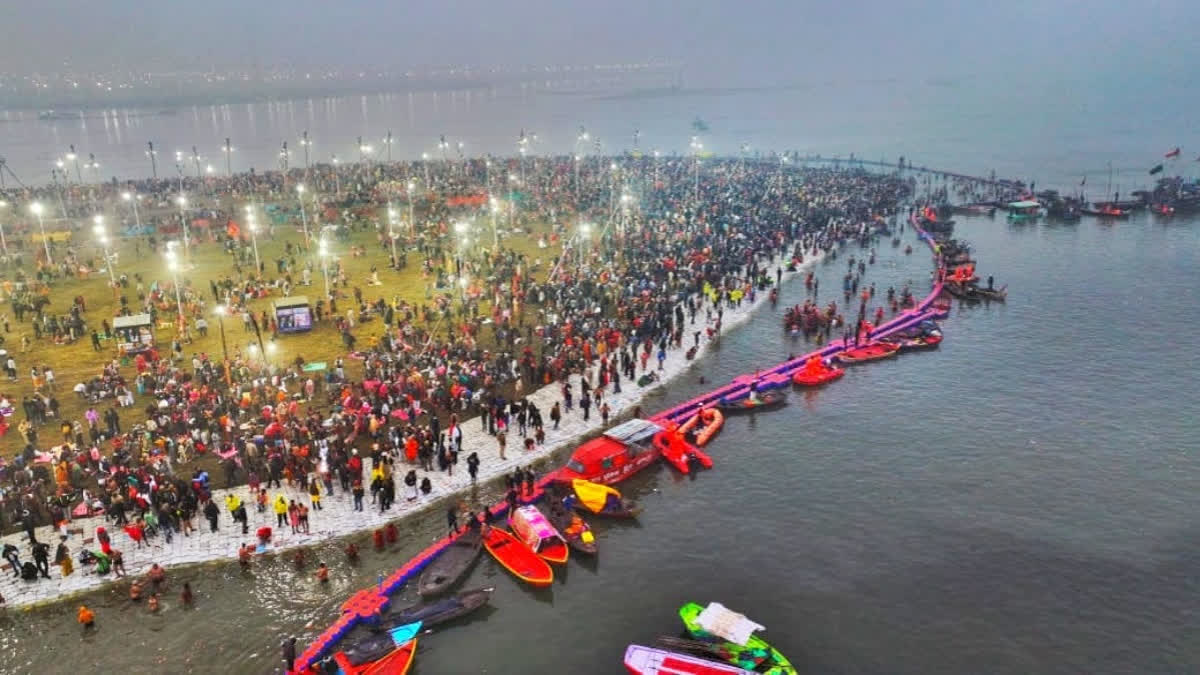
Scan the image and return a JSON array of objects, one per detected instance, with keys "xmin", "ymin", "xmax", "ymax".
[{"xmin": 557, "ymin": 419, "xmax": 665, "ymax": 485}]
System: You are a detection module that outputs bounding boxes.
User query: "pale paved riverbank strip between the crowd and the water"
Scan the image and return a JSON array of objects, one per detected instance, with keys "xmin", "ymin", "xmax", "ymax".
[{"xmin": 0, "ymin": 249, "xmax": 822, "ymax": 607}]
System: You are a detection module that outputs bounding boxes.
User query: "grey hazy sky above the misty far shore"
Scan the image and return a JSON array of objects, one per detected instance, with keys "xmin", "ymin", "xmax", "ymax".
[{"xmin": 9, "ymin": 0, "xmax": 1200, "ymax": 85}]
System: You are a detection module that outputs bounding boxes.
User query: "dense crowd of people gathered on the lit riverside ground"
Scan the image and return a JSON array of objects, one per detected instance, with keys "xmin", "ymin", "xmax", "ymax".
[{"xmin": 0, "ymin": 151, "xmax": 912, "ymax": 598}]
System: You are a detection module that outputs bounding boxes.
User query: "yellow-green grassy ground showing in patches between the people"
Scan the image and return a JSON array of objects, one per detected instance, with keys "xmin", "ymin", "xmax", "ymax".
[{"xmin": 0, "ymin": 199, "xmax": 558, "ymax": 456}]
